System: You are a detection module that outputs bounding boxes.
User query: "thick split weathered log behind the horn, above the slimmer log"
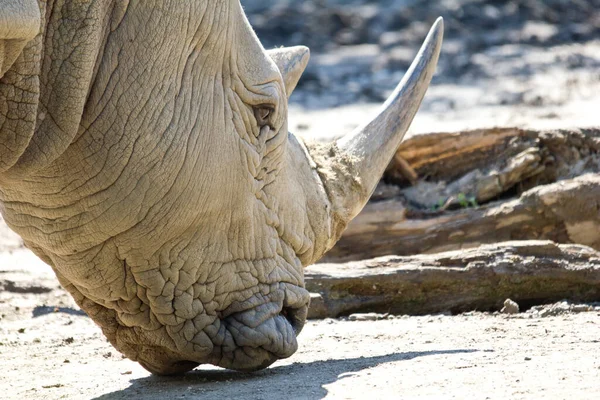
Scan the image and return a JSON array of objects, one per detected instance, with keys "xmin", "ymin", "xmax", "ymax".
[{"xmin": 324, "ymin": 129, "xmax": 600, "ymax": 262}]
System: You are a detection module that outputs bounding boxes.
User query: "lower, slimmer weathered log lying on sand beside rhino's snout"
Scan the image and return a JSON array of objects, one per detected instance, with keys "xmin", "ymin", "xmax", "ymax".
[{"xmin": 305, "ymin": 241, "xmax": 600, "ymax": 318}]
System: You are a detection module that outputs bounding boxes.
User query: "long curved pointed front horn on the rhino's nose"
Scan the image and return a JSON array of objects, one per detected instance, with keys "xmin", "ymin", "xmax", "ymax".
[{"xmin": 326, "ymin": 18, "xmax": 444, "ymax": 222}]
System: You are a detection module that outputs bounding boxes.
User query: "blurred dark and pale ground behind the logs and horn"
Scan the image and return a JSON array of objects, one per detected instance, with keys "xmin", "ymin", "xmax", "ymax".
[{"xmin": 241, "ymin": 0, "xmax": 600, "ymax": 138}]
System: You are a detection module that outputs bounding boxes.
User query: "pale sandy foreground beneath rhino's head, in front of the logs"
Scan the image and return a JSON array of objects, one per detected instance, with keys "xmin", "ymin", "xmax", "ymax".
[{"xmin": 0, "ymin": 250, "xmax": 600, "ymax": 399}]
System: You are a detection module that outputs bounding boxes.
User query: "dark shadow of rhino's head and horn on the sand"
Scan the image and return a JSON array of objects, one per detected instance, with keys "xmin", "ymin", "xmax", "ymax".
[{"xmin": 93, "ymin": 349, "xmax": 478, "ymax": 400}]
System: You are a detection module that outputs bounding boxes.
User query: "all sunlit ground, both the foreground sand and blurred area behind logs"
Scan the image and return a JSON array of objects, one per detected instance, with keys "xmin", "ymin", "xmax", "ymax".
[{"xmin": 0, "ymin": 0, "xmax": 600, "ymax": 399}]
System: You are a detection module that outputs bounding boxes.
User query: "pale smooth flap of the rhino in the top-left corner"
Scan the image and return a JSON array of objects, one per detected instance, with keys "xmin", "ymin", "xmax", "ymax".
[{"xmin": 0, "ymin": 0, "xmax": 41, "ymax": 78}]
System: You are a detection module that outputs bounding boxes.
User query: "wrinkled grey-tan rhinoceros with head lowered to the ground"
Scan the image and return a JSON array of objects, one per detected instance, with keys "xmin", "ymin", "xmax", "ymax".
[{"xmin": 0, "ymin": 0, "xmax": 443, "ymax": 374}]
